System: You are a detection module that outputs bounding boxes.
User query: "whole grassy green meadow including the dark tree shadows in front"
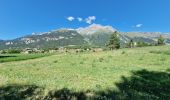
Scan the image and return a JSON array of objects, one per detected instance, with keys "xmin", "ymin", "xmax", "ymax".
[{"xmin": 0, "ymin": 46, "xmax": 170, "ymax": 100}]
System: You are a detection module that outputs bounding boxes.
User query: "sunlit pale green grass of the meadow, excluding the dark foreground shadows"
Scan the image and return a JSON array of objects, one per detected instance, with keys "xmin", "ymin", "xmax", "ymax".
[{"xmin": 0, "ymin": 46, "xmax": 170, "ymax": 91}]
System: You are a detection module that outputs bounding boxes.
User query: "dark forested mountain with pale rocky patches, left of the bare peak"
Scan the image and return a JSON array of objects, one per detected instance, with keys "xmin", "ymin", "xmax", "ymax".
[{"xmin": 0, "ymin": 29, "xmax": 87, "ymax": 49}]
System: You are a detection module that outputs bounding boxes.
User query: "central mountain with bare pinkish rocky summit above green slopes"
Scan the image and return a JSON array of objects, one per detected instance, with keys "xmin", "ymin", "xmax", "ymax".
[{"xmin": 76, "ymin": 24, "xmax": 128, "ymax": 46}]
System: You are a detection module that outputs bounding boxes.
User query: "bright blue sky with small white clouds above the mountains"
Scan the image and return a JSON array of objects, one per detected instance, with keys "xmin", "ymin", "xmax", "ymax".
[{"xmin": 0, "ymin": 0, "xmax": 170, "ymax": 39}]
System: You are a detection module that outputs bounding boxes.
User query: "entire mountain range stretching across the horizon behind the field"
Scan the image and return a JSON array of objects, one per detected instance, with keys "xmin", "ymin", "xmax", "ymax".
[{"xmin": 0, "ymin": 24, "xmax": 170, "ymax": 49}]
